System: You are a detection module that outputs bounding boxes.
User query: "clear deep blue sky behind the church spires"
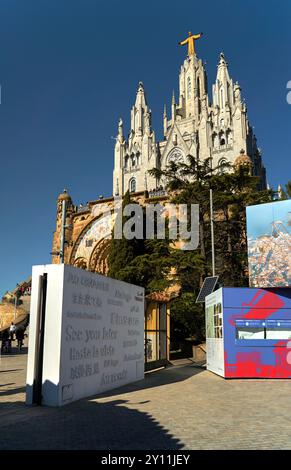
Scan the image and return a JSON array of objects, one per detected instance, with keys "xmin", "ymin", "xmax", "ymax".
[{"xmin": 0, "ymin": 0, "xmax": 291, "ymax": 294}]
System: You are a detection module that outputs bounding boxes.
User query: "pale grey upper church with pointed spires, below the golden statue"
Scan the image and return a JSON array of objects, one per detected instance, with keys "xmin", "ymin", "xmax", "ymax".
[{"xmin": 113, "ymin": 53, "xmax": 266, "ymax": 195}]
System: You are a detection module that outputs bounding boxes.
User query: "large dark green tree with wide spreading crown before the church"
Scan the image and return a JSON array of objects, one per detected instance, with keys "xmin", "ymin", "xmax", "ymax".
[{"xmin": 151, "ymin": 156, "xmax": 273, "ymax": 340}]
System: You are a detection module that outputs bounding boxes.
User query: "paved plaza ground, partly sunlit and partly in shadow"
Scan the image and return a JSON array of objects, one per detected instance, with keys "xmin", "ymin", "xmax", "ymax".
[{"xmin": 0, "ymin": 351, "xmax": 291, "ymax": 450}]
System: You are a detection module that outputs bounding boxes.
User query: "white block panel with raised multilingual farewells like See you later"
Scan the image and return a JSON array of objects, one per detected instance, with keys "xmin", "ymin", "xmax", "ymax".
[{"xmin": 27, "ymin": 265, "xmax": 144, "ymax": 406}]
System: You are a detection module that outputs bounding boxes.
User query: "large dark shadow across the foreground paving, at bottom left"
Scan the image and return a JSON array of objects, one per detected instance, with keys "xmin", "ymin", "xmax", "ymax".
[{"xmin": 0, "ymin": 400, "xmax": 183, "ymax": 450}]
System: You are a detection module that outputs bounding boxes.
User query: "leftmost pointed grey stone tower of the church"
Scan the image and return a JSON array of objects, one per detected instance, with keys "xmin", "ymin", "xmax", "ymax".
[{"xmin": 113, "ymin": 82, "xmax": 157, "ymax": 196}]
